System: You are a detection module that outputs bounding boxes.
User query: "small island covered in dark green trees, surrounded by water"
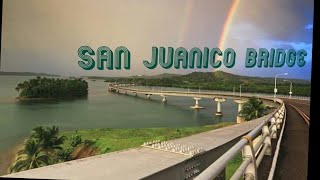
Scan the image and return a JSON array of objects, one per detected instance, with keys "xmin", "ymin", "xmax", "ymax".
[{"xmin": 15, "ymin": 76, "xmax": 88, "ymax": 98}]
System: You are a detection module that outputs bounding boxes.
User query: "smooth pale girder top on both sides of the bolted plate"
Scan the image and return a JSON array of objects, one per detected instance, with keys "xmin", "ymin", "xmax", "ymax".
[{"xmin": 3, "ymin": 115, "xmax": 270, "ymax": 179}]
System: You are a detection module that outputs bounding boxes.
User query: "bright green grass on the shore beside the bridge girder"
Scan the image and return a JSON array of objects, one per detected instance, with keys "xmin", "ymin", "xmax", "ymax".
[{"xmin": 61, "ymin": 122, "xmax": 242, "ymax": 179}]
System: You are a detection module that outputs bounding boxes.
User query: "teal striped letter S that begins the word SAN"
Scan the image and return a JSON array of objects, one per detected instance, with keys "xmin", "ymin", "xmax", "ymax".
[{"xmin": 78, "ymin": 46, "xmax": 95, "ymax": 70}]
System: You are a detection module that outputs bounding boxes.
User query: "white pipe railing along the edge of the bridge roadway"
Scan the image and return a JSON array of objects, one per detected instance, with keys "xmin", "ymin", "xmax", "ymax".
[{"xmin": 195, "ymin": 99, "xmax": 286, "ymax": 180}]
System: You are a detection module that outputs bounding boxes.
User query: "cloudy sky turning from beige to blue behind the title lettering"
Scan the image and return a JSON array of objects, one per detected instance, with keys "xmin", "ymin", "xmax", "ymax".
[{"xmin": 0, "ymin": 0, "xmax": 314, "ymax": 79}]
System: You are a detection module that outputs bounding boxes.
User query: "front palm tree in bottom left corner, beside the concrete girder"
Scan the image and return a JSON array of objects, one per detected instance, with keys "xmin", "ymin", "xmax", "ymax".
[{"xmin": 9, "ymin": 139, "xmax": 50, "ymax": 173}]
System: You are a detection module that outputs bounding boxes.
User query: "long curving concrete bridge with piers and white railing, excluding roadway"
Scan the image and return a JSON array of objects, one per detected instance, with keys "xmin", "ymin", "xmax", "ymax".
[{"xmin": 4, "ymin": 85, "xmax": 307, "ymax": 179}]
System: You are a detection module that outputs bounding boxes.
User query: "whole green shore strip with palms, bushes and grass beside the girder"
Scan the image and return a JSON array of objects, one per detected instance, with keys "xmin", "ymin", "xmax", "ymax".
[{"xmin": 9, "ymin": 122, "xmax": 234, "ymax": 172}]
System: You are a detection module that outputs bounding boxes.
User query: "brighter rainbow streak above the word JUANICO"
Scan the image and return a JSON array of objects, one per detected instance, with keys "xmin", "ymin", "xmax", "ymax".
[{"xmin": 218, "ymin": 0, "xmax": 240, "ymax": 51}]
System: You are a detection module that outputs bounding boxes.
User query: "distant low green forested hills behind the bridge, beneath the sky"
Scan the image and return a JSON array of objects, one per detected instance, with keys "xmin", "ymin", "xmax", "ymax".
[{"xmin": 105, "ymin": 71, "xmax": 311, "ymax": 96}]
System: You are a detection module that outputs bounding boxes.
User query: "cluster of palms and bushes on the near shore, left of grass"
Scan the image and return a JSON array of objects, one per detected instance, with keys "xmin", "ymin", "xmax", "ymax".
[{"xmin": 9, "ymin": 126, "xmax": 99, "ymax": 173}]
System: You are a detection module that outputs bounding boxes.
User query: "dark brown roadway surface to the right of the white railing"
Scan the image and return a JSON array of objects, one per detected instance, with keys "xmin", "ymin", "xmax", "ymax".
[{"xmin": 274, "ymin": 99, "xmax": 310, "ymax": 180}]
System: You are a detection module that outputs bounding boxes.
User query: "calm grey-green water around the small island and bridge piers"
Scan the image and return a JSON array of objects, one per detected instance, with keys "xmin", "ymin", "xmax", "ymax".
[{"xmin": 0, "ymin": 76, "xmax": 237, "ymax": 152}]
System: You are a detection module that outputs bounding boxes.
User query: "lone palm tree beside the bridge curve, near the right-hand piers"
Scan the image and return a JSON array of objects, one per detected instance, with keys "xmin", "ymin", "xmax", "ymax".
[{"xmin": 240, "ymin": 97, "xmax": 267, "ymax": 121}]
